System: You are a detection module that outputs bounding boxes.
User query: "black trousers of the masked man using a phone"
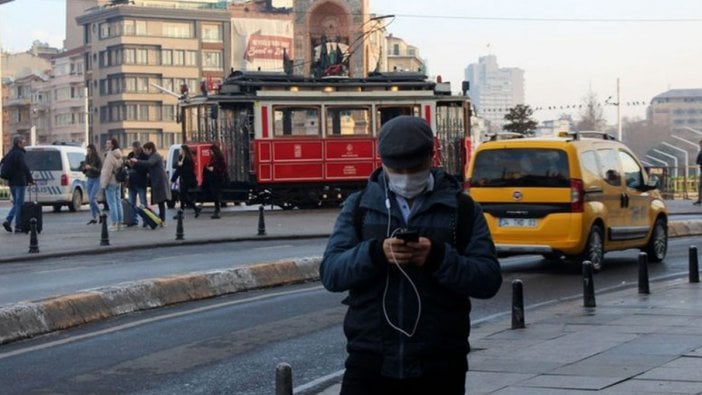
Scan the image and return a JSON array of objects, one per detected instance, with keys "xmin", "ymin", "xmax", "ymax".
[{"xmin": 340, "ymin": 356, "xmax": 467, "ymax": 395}]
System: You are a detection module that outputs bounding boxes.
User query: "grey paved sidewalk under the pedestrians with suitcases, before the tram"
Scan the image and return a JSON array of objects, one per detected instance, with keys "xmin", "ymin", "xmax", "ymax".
[{"xmin": 0, "ymin": 206, "xmax": 337, "ymax": 263}]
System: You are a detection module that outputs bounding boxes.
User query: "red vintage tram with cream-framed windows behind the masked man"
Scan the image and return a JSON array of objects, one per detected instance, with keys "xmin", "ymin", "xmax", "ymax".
[{"xmin": 181, "ymin": 71, "xmax": 471, "ymax": 208}]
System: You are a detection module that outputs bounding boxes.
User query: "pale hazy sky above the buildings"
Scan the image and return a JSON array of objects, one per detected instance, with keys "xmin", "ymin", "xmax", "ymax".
[{"xmin": 0, "ymin": 0, "xmax": 702, "ymax": 123}]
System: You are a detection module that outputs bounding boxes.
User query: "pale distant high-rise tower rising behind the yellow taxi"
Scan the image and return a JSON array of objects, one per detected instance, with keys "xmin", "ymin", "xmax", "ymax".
[{"xmin": 465, "ymin": 55, "xmax": 524, "ymax": 132}]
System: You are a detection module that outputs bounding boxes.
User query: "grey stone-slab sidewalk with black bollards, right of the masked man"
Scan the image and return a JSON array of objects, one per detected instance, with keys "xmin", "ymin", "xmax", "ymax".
[{"xmin": 320, "ymin": 279, "xmax": 702, "ymax": 395}]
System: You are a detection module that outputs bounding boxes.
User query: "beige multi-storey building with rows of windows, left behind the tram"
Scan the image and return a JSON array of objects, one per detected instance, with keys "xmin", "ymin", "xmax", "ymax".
[{"xmin": 77, "ymin": 0, "xmax": 231, "ymax": 149}]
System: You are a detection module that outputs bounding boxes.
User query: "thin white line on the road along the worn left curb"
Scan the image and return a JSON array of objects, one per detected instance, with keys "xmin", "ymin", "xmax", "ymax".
[{"xmin": 0, "ymin": 285, "xmax": 324, "ymax": 360}]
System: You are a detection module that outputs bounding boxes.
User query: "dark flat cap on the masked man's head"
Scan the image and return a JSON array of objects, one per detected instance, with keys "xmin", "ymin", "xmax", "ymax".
[{"xmin": 378, "ymin": 115, "xmax": 434, "ymax": 169}]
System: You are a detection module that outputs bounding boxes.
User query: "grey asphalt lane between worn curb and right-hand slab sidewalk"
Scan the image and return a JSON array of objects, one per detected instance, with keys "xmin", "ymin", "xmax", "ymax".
[{"xmin": 0, "ymin": 237, "xmax": 702, "ymax": 394}]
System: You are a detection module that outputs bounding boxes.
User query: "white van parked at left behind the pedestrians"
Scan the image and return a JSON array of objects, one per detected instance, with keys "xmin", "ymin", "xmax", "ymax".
[{"xmin": 25, "ymin": 145, "xmax": 88, "ymax": 211}]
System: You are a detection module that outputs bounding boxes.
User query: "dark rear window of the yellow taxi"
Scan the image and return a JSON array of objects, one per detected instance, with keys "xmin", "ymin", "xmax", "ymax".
[{"xmin": 471, "ymin": 148, "xmax": 570, "ymax": 188}]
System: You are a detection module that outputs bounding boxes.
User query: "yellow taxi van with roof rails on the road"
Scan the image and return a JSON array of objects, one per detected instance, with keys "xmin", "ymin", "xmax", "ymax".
[{"xmin": 466, "ymin": 132, "xmax": 668, "ymax": 270}]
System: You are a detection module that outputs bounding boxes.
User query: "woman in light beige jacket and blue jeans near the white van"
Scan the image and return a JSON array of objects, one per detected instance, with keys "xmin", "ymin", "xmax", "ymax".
[{"xmin": 100, "ymin": 138, "xmax": 124, "ymax": 231}]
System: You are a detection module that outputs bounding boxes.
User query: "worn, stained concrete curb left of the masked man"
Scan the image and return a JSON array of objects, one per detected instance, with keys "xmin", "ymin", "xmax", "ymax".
[{"xmin": 0, "ymin": 257, "xmax": 321, "ymax": 344}]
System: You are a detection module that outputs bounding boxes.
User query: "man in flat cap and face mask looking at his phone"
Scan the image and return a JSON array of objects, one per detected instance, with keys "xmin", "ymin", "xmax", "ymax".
[{"xmin": 320, "ymin": 116, "xmax": 502, "ymax": 395}]
